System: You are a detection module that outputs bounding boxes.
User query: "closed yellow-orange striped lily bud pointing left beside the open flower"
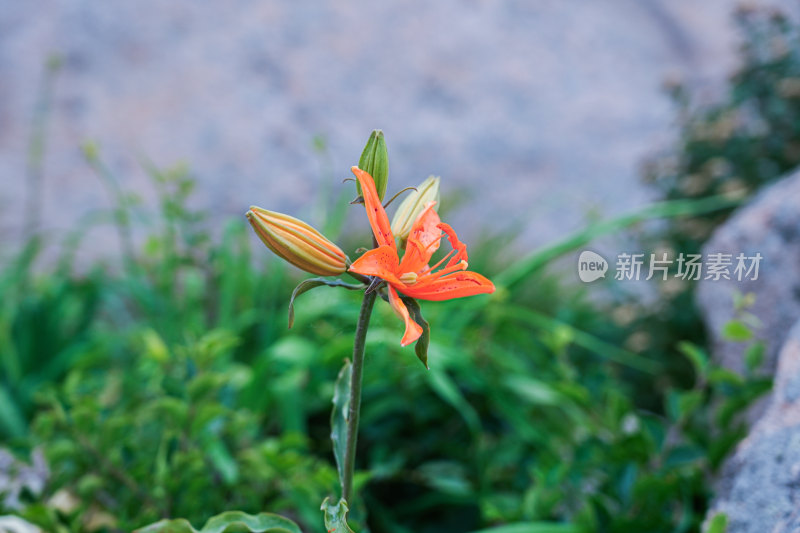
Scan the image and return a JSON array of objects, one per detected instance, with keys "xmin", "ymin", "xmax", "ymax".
[{"xmin": 247, "ymin": 206, "xmax": 347, "ymax": 276}]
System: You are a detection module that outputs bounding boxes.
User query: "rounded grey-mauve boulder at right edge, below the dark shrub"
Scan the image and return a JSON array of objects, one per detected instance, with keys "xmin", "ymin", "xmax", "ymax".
[{"xmin": 697, "ymin": 173, "xmax": 800, "ymax": 376}]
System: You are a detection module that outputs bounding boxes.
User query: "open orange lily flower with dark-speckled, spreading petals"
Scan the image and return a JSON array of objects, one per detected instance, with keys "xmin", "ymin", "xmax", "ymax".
[{"xmin": 349, "ymin": 167, "xmax": 494, "ymax": 346}]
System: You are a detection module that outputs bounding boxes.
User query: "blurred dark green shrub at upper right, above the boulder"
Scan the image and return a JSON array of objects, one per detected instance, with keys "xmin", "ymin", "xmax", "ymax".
[{"xmin": 646, "ymin": 7, "xmax": 800, "ymax": 247}]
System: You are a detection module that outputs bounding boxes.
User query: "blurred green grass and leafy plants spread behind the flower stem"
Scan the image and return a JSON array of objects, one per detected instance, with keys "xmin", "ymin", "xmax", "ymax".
[{"xmin": 0, "ymin": 153, "xmax": 765, "ymax": 533}]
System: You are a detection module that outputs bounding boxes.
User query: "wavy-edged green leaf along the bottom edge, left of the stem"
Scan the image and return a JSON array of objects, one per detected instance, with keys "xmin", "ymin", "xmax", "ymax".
[{"xmin": 134, "ymin": 511, "xmax": 302, "ymax": 533}]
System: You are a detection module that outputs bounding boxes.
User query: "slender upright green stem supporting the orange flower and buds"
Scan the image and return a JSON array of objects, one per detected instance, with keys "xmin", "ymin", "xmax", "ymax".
[{"xmin": 342, "ymin": 291, "xmax": 378, "ymax": 502}]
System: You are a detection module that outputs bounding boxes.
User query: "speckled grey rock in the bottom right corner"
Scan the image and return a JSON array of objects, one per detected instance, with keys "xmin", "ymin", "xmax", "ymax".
[{"xmin": 708, "ymin": 322, "xmax": 800, "ymax": 533}]
